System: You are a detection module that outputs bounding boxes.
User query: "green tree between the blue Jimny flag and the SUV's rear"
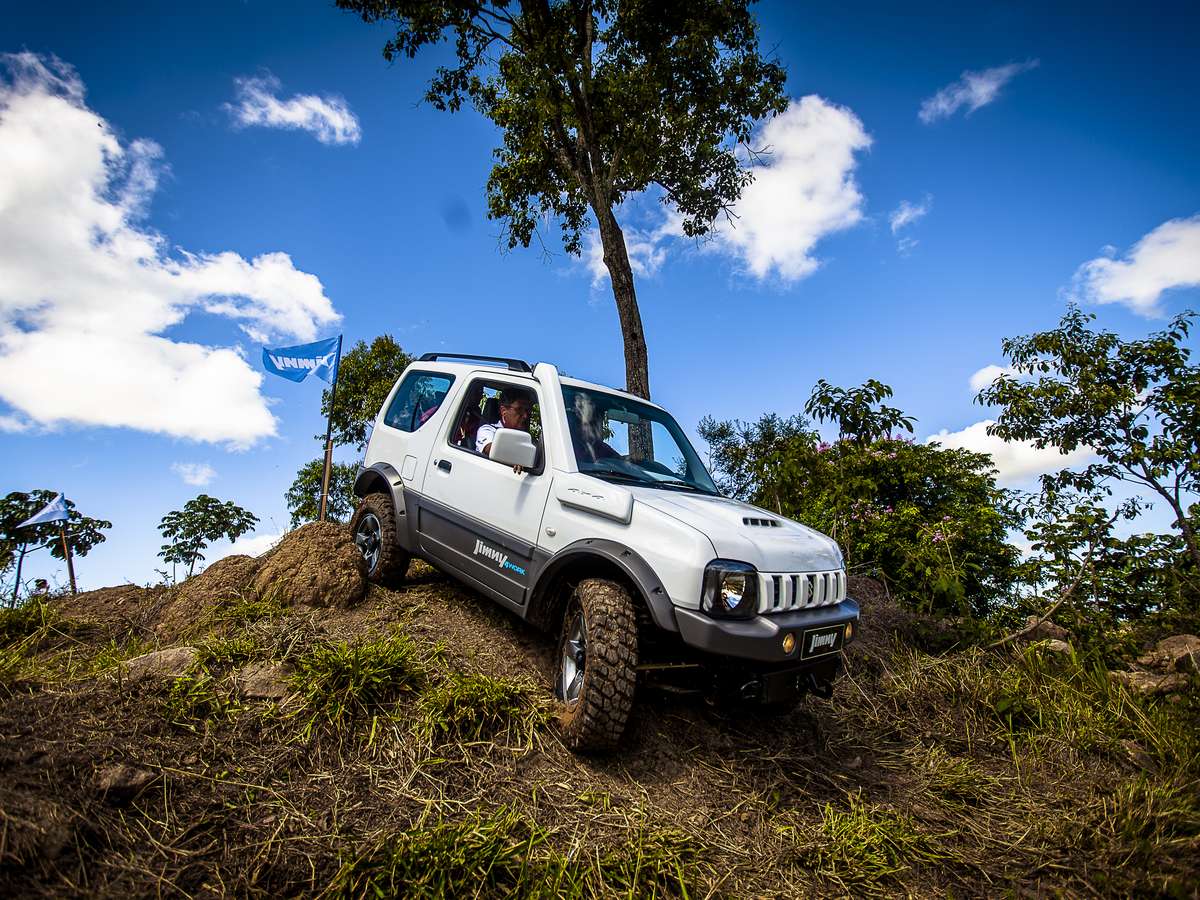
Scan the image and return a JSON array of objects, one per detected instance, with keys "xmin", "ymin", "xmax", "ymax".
[{"xmin": 319, "ymin": 335, "xmax": 413, "ymax": 453}]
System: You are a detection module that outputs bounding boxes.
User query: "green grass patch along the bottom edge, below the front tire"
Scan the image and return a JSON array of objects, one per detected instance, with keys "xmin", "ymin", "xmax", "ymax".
[{"xmin": 324, "ymin": 806, "xmax": 702, "ymax": 898}]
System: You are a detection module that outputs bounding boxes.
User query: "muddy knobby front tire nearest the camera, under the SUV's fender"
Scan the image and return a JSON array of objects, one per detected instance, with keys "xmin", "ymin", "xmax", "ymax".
[{"xmin": 554, "ymin": 578, "xmax": 637, "ymax": 752}]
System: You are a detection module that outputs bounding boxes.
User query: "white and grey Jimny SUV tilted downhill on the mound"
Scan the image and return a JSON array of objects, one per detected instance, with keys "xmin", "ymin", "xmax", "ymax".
[{"xmin": 350, "ymin": 354, "xmax": 858, "ymax": 750}]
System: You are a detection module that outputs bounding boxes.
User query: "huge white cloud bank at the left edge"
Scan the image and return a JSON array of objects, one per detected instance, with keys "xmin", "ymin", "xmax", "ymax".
[{"xmin": 0, "ymin": 53, "xmax": 340, "ymax": 446}]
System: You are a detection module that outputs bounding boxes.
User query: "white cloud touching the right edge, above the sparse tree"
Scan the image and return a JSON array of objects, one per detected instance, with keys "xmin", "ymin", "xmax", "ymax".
[{"xmin": 1068, "ymin": 215, "xmax": 1200, "ymax": 317}]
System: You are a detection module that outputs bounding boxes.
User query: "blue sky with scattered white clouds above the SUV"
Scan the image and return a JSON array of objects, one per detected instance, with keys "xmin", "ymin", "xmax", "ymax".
[{"xmin": 0, "ymin": 0, "xmax": 1200, "ymax": 587}]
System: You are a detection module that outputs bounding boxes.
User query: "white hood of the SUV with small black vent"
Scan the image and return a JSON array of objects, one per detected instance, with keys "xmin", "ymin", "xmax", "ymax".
[{"xmin": 630, "ymin": 487, "xmax": 842, "ymax": 572}]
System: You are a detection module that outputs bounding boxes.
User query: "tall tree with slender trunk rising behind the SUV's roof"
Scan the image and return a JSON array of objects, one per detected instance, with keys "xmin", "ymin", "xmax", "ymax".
[{"xmin": 337, "ymin": 0, "xmax": 787, "ymax": 397}]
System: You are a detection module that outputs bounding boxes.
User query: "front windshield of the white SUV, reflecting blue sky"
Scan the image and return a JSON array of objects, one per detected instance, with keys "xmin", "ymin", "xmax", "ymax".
[{"xmin": 563, "ymin": 385, "xmax": 718, "ymax": 494}]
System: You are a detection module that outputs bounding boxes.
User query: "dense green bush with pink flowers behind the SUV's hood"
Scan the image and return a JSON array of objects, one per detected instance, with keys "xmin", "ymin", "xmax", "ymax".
[{"xmin": 700, "ymin": 415, "xmax": 1016, "ymax": 614}]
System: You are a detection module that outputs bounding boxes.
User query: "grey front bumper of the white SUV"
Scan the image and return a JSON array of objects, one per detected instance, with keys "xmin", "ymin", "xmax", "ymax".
[{"xmin": 674, "ymin": 599, "xmax": 858, "ymax": 665}]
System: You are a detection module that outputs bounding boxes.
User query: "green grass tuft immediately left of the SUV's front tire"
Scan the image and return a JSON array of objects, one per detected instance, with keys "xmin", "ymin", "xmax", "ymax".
[{"xmin": 416, "ymin": 671, "xmax": 551, "ymax": 745}]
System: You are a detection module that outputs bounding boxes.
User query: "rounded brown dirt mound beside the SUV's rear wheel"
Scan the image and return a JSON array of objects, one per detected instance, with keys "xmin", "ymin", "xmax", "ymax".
[{"xmin": 253, "ymin": 522, "xmax": 367, "ymax": 606}]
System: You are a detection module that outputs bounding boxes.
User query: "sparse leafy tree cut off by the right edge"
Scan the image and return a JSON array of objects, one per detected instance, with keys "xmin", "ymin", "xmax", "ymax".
[{"xmin": 976, "ymin": 305, "xmax": 1200, "ymax": 569}]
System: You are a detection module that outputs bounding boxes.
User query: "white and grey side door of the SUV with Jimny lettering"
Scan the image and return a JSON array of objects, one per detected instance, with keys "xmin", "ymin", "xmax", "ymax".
[{"xmin": 418, "ymin": 374, "xmax": 551, "ymax": 612}]
